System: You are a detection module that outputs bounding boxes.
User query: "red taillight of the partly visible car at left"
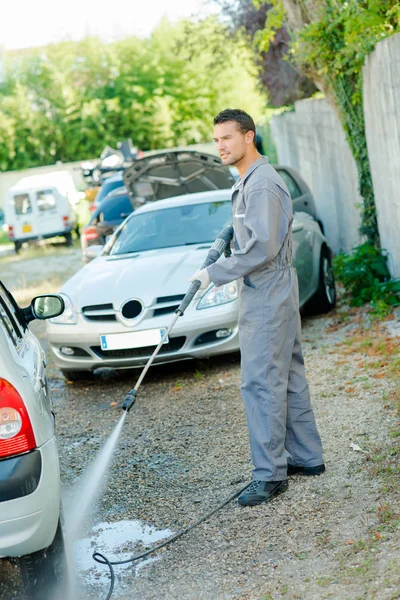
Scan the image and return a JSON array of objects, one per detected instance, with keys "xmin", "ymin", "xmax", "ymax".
[{"xmin": 0, "ymin": 378, "xmax": 36, "ymax": 458}]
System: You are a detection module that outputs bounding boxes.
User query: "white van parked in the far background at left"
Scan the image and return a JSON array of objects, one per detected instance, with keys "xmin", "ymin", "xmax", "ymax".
[{"xmin": 5, "ymin": 171, "xmax": 79, "ymax": 252}]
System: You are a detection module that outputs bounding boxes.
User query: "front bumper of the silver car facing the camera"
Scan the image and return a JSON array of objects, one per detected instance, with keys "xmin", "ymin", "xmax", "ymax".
[{"xmin": 47, "ymin": 307, "xmax": 239, "ymax": 371}]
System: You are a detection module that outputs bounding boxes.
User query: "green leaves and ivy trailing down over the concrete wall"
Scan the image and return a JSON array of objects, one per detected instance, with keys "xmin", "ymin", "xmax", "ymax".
[{"xmin": 254, "ymin": 0, "xmax": 400, "ymax": 246}]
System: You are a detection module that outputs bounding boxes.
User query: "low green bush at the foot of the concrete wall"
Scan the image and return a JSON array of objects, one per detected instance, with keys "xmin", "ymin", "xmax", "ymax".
[{"xmin": 333, "ymin": 242, "xmax": 400, "ymax": 316}]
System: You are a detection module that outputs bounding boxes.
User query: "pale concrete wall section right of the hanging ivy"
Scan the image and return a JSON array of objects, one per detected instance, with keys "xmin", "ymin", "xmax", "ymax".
[{"xmin": 363, "ymin": 34, "xmax": 400, "ymax": 277}]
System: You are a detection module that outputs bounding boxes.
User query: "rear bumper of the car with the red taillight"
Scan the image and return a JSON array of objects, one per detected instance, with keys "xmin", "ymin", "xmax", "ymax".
[{"xmin": 0, "ymin": 437, "xmax": 60, "ymax": 557}]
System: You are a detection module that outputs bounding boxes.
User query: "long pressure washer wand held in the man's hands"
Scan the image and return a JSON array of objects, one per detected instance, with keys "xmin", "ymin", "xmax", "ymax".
[{"xmin": 122, "ymin": 225, "xmax": 233, "ymax": 412}]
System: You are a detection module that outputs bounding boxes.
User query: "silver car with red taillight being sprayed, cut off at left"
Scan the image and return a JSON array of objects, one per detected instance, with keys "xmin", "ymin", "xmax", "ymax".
[{"xmin": 0, "ymin": 282, "xmax": 64, "ymax": 600}]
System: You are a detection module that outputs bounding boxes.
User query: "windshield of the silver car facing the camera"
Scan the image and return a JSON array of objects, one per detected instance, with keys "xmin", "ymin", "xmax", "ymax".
[{"xmin": 105, "ymin": 200, "xmax": 232, "ymax": 255}]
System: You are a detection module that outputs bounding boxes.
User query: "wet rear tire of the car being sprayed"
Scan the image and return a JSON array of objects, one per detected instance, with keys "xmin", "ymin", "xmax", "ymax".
[{"xmin": 19, "ymin": 519, "xmax": 67, "ymax": 600}]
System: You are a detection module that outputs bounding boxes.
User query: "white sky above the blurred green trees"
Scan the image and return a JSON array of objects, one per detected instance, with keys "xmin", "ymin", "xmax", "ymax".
[{"xmin": 0, "ymin": 0, "xmax": 218, "ymax": 50}]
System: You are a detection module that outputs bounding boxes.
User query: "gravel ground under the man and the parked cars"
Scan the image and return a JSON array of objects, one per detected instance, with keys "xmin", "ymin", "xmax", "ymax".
[{"xmin": 0, "ymin": 250, "xmax": 400, "ymax": 600}]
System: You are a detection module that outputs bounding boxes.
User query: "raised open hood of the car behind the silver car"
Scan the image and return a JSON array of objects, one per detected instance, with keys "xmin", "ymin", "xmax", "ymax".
[{"xmin": 124, "ymin": 150, "xmax": 235, "ymax": 206}]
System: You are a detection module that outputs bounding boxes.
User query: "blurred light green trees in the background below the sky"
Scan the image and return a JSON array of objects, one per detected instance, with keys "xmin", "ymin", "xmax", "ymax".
[{"xmin": 0, "ymin": 18, "xmax": 266, "ymax": 170}]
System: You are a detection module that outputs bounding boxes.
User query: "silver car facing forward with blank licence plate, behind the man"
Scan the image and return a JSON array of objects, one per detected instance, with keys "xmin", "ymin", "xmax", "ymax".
[{"xmin": 47, "ymin": 190, "xmax": 335, "ymax": 380}]
